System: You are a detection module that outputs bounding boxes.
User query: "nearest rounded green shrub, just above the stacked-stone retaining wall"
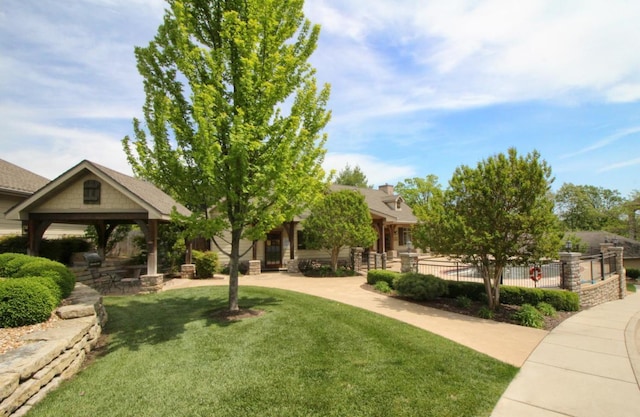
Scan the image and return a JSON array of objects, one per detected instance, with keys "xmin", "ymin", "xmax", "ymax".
[{"xmin": 0, "ymin": 279, "xmax": 55, "ymax": 327}]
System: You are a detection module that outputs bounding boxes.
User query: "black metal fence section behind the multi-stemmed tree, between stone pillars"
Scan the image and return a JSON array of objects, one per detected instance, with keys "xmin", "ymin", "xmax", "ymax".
[{"xmin": 418, "ymin": 259, "xmax": 562, "ymax": 288}]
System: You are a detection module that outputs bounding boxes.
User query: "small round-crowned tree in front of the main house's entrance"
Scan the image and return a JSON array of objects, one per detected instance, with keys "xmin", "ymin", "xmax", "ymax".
[{"xmin": 303, "ymin": 190, "xmax": 378, "ymax": 272}]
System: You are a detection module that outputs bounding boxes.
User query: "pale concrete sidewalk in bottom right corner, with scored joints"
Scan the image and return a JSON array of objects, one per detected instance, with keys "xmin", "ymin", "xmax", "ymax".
[{"xmin": 491, "ymin": 294, "xmax": 640, "ymax": 417}]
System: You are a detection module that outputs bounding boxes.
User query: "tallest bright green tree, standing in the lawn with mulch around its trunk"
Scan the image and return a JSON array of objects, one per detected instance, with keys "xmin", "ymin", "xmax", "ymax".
[{"xmin": 123, "ymin": 0, "xmax": 330, "ymax": 311}]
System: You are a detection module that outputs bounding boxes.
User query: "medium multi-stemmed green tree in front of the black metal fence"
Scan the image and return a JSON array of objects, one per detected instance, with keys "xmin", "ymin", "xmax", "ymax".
[{"xmin": 414, "ymin": 148, "xmax": 559, "ymax": 309}]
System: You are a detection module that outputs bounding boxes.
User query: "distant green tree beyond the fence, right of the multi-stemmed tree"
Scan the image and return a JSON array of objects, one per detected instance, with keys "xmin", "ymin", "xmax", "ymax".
[{"xmin": 555, "ymin": 183, "xmax": 628, "ymax": 235}]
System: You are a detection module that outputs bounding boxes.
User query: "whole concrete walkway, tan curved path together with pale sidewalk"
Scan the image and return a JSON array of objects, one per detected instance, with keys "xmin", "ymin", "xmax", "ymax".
[{"xmin": 165, "ymin": 273, "xmax": 640, "ymax": 417}]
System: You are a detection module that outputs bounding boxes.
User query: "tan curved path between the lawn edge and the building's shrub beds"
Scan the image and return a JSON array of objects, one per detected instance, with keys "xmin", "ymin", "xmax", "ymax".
[{"xmin": 165, "ymin": 273, "xmax": 548, "ymax": 367}]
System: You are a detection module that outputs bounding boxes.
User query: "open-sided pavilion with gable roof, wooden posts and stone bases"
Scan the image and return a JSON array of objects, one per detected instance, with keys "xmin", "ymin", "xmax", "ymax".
[{"xmin": 5, "ymin": 160, "xmax": 191, "ymax": 290}]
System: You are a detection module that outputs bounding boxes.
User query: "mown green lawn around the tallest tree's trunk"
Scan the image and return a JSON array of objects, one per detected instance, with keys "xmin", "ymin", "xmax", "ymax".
[{"xmin": 29, "ymin": 287, "xmax": 517, "ymax": 417}]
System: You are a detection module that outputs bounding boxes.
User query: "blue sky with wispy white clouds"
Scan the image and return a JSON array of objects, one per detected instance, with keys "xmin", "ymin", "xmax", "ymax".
[{"xmin": 0, "ymin": 0, "xmax": 640, "ymax": 197}]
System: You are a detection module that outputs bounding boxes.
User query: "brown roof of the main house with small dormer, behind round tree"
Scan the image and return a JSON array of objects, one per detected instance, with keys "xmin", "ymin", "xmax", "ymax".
[{"xmin": 331, "ymin": 184, "xmax": 418, "ymax": 224}]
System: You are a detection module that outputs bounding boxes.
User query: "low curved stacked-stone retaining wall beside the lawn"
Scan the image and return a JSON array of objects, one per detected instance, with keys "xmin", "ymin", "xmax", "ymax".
[{"xmin": 0, "ymin": 283, "xmax": 107, "ymax": 417}]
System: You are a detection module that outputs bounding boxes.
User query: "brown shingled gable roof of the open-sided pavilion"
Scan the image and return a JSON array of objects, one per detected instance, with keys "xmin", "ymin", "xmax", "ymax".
[{"xmin": 6, "ymin": 160, "xmax": 191, "ymax": 220}]
